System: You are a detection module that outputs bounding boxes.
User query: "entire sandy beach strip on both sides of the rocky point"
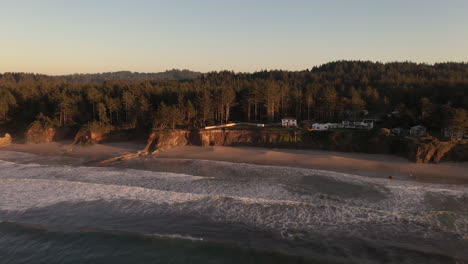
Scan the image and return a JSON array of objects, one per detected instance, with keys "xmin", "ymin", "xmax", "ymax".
[{"xmin": 0, "ymin": 141, "xmax": 468, "ymax": 184}]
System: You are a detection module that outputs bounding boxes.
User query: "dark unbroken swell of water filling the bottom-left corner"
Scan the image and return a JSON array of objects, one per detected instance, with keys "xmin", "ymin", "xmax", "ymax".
[{"xmin": 0, "ymin": 222, "xmax": 320, "ymax": 263}]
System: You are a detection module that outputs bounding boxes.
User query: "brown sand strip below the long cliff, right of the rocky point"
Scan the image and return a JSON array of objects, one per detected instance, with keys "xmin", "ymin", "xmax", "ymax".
[{"xmin": 155, "ymin": 146, "xmax": 468, "ymax": 184}]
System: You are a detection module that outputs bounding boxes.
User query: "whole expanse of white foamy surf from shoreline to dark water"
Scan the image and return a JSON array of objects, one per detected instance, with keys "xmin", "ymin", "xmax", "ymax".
[{"xmin": 0, "ymin": 152, "xmax": 468, "ymax": 240}]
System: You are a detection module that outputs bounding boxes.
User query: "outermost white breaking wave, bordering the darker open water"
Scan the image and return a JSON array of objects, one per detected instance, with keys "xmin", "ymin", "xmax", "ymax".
[{"xmin": 0, "ymin": 179, "xmax": 467, "ymax": 241}]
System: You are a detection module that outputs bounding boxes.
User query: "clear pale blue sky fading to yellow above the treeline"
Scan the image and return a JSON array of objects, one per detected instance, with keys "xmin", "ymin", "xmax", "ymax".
[{"xmin": 0, "ymin": 0, "xmax": 468, "ymax": 75}]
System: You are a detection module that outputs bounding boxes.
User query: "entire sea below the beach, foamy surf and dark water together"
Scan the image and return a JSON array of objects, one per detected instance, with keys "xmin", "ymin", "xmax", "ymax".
[{"xmin": 0, "ymin": 152, "xmax": 468, "ymax": 263}]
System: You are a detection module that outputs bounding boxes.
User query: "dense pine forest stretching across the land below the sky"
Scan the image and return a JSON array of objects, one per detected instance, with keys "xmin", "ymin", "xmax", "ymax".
[{"xmin": 0, "ymin": 61, "xmax": 468, "ymax": 133}]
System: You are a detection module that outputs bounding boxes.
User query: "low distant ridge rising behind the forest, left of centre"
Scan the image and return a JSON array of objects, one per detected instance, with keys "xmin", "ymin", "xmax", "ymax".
[{"xmin": 59, "ymin": 70, "xmax": 201, "ymax": 82}]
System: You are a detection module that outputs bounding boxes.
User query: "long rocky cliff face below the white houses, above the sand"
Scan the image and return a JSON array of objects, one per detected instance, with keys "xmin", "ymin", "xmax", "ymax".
[{"xmin": 144, "ymin": 129, "xmax": 468, "ymax": 163}]
